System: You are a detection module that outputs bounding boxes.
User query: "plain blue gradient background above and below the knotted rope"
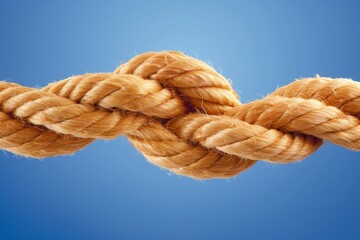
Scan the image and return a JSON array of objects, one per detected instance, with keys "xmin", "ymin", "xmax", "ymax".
[{"xmin": 0, "ymin": 0, "xmax": 360, "ymax": 240}]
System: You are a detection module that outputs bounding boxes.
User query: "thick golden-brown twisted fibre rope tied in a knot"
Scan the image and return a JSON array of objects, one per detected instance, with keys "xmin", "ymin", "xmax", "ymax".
[{"xmin": 0, "ymin": 52, "xmax": 360, "ymax": 179}]
